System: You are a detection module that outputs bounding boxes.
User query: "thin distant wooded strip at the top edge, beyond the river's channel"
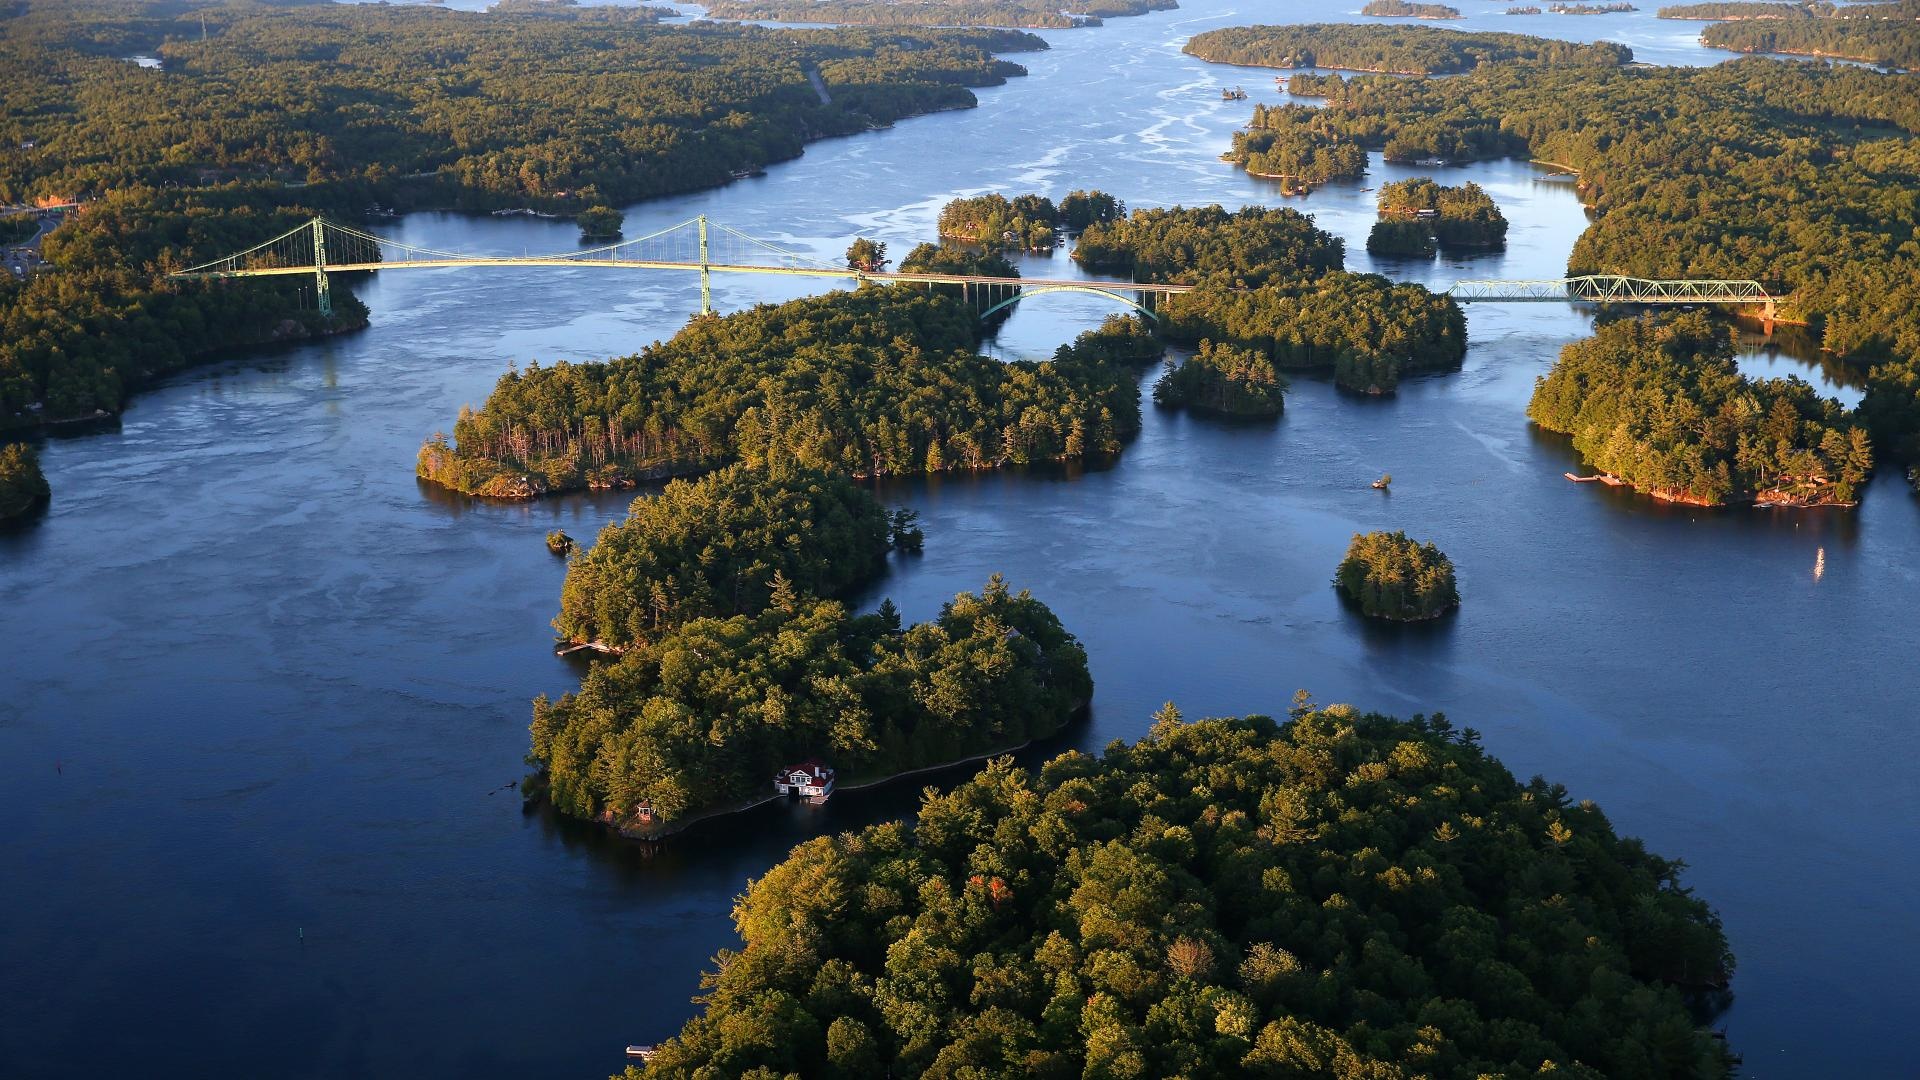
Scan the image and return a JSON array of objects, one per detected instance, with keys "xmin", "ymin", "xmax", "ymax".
[{"xmin": 707, "ymin": 0, "xmax": 1179, "ymax": 29}]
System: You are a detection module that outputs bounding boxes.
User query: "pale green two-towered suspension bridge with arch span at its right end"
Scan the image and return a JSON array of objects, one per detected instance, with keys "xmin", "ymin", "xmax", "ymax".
[{"xmin": 169, "ymin": 215, "xmax": 1194, "ymax": 319}]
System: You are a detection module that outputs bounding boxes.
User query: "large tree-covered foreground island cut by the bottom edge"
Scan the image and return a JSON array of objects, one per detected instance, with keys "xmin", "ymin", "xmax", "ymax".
[{"xmin": 628, "ymin": 703, "xmax": 1734, "ymax": 1080}]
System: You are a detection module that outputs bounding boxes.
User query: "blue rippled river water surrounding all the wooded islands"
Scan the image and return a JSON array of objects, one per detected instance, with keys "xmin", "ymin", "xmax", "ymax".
[{"xmin": 0, "ymin": 0, "xmax": 1920, "ymax": 1078}]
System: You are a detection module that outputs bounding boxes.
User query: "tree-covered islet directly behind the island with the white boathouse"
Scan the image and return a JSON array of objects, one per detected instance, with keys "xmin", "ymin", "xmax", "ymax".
[{"xmin": 553, "ymin": 465, "xmax": 918, "ymax": 650}]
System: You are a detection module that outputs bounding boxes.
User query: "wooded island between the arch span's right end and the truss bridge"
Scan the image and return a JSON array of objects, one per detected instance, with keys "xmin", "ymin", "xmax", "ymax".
[{"xmin": 1073, "ymin": 206, "xmax": 1467, "ymax": 394}]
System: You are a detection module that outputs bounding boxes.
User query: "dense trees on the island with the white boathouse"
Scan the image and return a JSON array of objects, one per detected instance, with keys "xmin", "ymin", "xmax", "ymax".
[{"xmin": 530, "ymin": 577, "xmax": 1092, "ymax": 834}]
